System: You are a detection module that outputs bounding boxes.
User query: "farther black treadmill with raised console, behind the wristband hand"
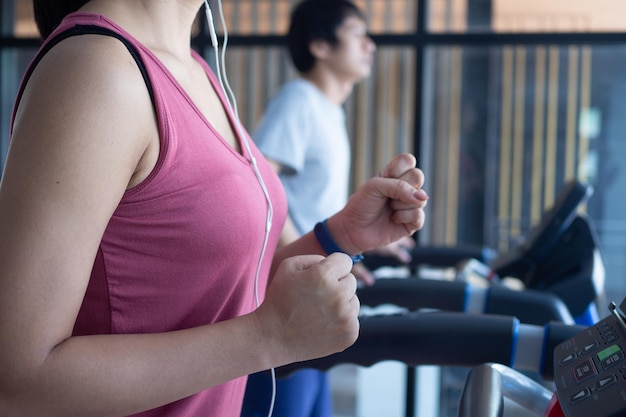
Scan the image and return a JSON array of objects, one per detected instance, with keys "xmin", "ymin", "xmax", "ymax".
[{"xmin": 358, "ymin": 180, "xmax": 604, "ymax": 325}]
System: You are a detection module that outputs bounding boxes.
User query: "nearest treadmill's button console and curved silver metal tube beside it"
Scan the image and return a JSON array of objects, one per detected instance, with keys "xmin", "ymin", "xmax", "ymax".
[{"xmin": 458, "ymin": 298, "xmax": 626, "ymax": 417}]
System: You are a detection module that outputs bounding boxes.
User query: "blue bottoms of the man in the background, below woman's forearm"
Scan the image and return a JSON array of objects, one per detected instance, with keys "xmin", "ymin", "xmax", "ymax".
[{"xmin": 241, "ymin": 369, "xmax": 332, "ymax": 417}]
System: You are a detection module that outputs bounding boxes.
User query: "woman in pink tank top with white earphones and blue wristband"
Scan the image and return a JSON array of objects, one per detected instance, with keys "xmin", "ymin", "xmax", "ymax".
[{"xmin": 0, "ymin": 0, "xmax": 428, "ymax": 417}]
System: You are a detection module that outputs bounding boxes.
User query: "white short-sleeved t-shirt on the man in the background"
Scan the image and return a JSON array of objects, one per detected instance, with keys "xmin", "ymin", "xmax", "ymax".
[{"xmin": 252, "ymin": 79, "xmax": 350, "ymax": 234}]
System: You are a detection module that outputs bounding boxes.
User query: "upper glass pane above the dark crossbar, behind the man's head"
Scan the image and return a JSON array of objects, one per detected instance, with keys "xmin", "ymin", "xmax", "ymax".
[{"xmin": 213, "ymin": 0, "xmax": 417, "ymax": 35}]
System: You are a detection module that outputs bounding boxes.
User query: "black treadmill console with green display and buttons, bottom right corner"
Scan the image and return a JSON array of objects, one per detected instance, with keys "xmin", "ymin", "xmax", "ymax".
[{"xmin": 554, "ymin": 299, "xmax": 626, "ymax": 417}]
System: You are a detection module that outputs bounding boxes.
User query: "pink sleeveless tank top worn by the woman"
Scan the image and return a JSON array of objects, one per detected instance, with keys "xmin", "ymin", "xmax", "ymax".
[{"xmin": 14, "ymin": 13, "xmax": 287, "ymax": 417}]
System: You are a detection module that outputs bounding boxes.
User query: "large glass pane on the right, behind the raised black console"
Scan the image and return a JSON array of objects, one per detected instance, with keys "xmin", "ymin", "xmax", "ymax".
[{"xmin": 420, "ymin": 45, "xmax": 626, "ymax": 299}]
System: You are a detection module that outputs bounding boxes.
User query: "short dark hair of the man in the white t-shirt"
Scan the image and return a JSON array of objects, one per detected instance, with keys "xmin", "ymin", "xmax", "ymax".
[{"xmin": 287, "ymin": 0, "xmax": 365, "ymax": 73}]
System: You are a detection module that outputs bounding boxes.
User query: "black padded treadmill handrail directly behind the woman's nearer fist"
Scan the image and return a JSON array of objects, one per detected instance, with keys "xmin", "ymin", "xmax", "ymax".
[{"xmin": 276, "ymin": 312, "xmax": 581, "ymax": 379}]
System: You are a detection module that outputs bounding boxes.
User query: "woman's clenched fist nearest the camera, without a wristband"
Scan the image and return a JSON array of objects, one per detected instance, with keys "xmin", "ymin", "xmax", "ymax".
[{"xmin": 254, "ymin": 253, "xmax": 359, "ymax": 366}]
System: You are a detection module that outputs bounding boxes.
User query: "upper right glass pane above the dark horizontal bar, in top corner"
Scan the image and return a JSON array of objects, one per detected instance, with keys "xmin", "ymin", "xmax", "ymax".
[{"xmin": 428, "ymin": 0, "xmax": 626, "ymax": 32}]
